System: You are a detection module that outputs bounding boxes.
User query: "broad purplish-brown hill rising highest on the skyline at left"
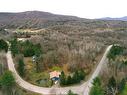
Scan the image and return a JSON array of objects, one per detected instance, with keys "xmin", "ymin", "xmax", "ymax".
[{"xmin": 0, "ymin": 11, "xmax": 86, "ymax": 28}]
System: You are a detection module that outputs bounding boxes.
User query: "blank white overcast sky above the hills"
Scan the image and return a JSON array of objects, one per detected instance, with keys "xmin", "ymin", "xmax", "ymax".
[{"xmin": 0, "ymin": 0, "xmax": 127, "ymax": 19}]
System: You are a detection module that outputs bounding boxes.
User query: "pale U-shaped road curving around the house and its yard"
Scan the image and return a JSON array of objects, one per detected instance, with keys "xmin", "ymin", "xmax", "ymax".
[{"xmin": 6, "ymin": 45, "xmax": 112, "ymax": 95}]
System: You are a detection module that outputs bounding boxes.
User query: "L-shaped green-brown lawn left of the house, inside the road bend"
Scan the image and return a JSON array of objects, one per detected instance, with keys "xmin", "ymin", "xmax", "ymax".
[{"xmin": 24, "ymin": 57, "xmax": 52, "ymax": 87}]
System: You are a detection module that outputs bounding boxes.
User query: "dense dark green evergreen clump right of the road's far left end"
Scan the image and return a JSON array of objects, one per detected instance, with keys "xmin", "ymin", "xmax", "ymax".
[{"xmin": 10, "ymin": 39, "xmax": 42, "ymax": 57}]
